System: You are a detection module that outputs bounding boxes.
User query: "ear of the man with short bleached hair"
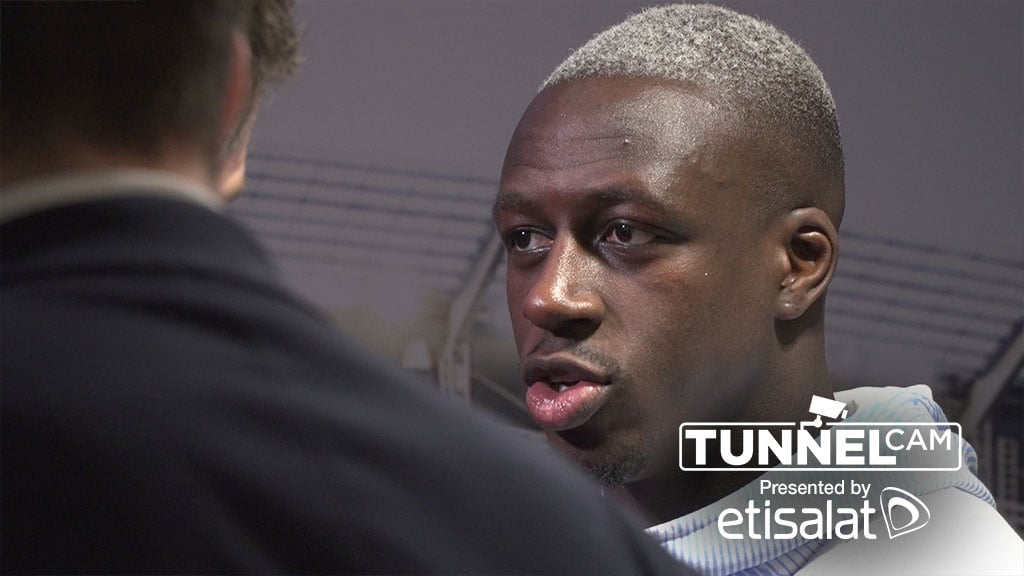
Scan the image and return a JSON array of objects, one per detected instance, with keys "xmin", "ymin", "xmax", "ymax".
[{"xmin": 775, "ymin": 208, "xmax": 839, "ymax": 320}]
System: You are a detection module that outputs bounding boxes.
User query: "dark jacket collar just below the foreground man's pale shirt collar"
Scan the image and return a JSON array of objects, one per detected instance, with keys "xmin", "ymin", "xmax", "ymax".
[{"xmin": 0, "ymin": 194, "xmax": 279, "ymax": 285}]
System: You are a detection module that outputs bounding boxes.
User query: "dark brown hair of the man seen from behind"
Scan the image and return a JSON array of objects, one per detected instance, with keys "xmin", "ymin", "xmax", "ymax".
[{"xmin": 0, "ymin": 0, "xmax": 297, "ymax": 169}]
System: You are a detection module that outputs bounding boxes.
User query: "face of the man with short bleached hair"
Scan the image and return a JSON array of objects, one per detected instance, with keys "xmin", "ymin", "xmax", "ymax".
[{"xmin": 495, "ymin": 78, "xmax": 833, "ymax": 517}]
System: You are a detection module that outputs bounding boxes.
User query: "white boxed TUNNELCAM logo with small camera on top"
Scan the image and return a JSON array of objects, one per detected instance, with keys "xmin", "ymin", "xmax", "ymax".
[{"xmin": 679, "ymin": 396, "xmax": 964, "ymax": 471}]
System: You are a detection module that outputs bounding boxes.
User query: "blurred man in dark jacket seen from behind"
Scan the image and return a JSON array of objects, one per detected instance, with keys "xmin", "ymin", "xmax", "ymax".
[{"xmin": 0, "ymin": 0, "xmax": 679, "ymax": 574}]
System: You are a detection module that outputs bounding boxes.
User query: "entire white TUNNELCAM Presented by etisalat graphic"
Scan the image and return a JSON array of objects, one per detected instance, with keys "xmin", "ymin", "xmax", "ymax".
[{"xmin": 679, "ymin": 396, "xmax": 963, "ymax": 540}]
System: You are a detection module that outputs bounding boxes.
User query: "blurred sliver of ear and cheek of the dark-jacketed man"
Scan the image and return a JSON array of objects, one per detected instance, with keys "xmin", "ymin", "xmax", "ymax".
[{"xmin": 216, "ymin": 32, "xmax": 255, "ymax": 200}]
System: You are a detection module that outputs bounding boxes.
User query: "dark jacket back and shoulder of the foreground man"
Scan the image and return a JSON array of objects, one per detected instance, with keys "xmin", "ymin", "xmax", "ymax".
[{"xmin": 0, "ymin": 198, "xmax": 682, "ymax": 574}]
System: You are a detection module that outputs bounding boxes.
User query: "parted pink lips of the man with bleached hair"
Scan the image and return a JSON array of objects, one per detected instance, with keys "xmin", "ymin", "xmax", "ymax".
[{"xmin": 523, "ymin": 359, "xmax": 611, "ymax": 431}]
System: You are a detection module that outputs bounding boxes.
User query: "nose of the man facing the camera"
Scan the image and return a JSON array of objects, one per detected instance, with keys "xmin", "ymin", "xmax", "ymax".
[{"xmin": 522, "ymin": 240, "xmax": 605, "ymax": 339}]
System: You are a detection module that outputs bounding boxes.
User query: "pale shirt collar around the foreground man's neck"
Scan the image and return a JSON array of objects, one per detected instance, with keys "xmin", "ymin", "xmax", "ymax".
[{"xmin": 0, "ymin": 169, "xmax": 224, "ymax": 223}]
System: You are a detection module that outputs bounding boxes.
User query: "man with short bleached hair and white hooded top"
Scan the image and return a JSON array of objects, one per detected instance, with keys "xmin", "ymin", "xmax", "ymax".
[{"xmin": 495, "ymin": 5, "xmax": 1024, "ymax": 574}]
